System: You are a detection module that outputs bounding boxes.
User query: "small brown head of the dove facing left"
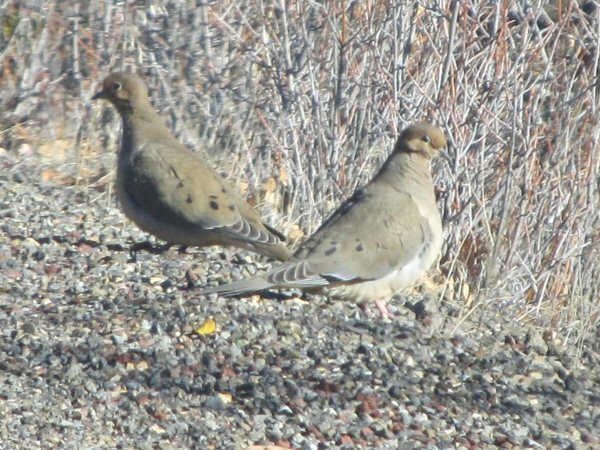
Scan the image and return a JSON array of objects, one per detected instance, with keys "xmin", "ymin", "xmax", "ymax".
[{"xmin": 92, "ymin": 72, "xmax": 149, "ymax": 114}]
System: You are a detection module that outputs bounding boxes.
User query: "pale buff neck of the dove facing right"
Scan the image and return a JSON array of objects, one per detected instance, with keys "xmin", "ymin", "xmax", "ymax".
[{"xmin": 380, "ymin": 153, "xmax": 433, "ymax": 196}]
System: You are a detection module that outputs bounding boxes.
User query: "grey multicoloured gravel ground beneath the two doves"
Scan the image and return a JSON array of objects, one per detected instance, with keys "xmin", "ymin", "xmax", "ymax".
[{"xmin": 0, "ymin": 154, "xmax": 600, "ymax": 449}]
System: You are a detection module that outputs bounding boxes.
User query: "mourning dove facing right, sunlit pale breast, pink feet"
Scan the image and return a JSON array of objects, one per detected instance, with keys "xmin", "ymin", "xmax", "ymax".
[{"xmin": 200, "ymin": 123, "xmax": 446, "ymax": 315}]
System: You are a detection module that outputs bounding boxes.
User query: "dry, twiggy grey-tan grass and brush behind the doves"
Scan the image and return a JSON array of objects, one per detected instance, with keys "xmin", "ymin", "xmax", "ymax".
[{"xmin": 0, "ymin": 0, "xmax": 600, "ymax": 352}]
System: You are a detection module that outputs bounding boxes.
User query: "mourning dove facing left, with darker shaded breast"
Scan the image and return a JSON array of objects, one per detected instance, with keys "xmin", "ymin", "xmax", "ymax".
[{"xmin": 92, "ymin": 72, "xmax": 291, "ymax": 261}]
